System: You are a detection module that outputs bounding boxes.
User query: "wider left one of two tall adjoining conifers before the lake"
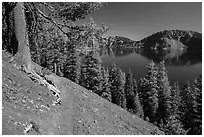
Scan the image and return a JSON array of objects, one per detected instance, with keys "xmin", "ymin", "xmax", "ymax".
[{"xmin": 138, "ymin": 61, "xmax": 158, "ymax": 123}]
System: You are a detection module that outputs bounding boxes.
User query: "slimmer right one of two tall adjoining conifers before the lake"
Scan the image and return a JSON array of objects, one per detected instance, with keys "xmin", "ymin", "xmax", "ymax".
[{"xmin": 157, "ymin": 61, "xmax": 171, "ymax": 124}]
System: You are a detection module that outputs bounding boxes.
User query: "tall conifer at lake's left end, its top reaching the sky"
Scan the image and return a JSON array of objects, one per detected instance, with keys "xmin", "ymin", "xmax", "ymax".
[{"xmin": 76, "ymin": 19, "xmax": 107, "ymax": 90}]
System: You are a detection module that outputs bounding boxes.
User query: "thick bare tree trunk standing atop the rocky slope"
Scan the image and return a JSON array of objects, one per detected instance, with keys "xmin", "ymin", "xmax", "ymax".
[{"xmin": 13, "ymin": 2, "xmax": 32, "ymax": 73}]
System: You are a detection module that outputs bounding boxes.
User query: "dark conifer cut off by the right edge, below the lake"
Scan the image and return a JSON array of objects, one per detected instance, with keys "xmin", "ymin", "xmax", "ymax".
[{"xmin": 181, "ymin": 80, "xmax": 202, "ymax": 135}]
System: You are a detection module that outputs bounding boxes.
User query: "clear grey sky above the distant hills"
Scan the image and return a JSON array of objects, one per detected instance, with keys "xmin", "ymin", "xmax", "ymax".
[{"xmin": 75, "ymin": 2, "xmax": 202, "ymax": 40}]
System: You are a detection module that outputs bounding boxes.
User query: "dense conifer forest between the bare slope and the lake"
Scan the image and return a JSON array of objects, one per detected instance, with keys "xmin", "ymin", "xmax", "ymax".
[{"xmin": 2, "ymin": 3, "xmax": 202, "ymax": 135}]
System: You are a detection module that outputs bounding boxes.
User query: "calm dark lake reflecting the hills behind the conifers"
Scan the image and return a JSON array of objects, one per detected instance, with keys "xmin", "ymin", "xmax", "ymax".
[{"xmin": 101, "ymin": 47, "xmax": 202, "ymax": 86}]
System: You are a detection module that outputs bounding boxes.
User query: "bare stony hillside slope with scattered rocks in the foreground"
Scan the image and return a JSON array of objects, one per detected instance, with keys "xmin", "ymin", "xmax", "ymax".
[{"xmin": 2, "ymin": 51, "xmax": 163, "ymax": 135}]
